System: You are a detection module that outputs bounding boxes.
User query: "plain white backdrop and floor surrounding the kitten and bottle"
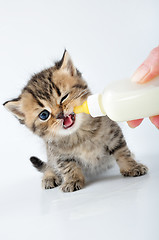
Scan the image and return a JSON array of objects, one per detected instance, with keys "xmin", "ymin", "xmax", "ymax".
[{"xmin": 0, "ymin": 0, "xmax": 159, "ymax": 240}]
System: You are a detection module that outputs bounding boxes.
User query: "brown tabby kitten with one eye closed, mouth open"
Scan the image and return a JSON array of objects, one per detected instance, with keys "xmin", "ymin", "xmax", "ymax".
[{"xmin": 4, "ymin": 50, "xmax": 148, "ymax": 192}]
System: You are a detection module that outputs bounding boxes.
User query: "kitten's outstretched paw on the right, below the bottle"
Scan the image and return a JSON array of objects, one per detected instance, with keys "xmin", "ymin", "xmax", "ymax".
[{"xmin": 120, "ymin": 163, "xmax": 148, "ymax": 177}]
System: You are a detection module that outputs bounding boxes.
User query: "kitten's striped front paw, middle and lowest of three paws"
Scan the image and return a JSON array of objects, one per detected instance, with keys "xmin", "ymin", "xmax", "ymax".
[{"xmin": 61, "ymin": 180, "xmax": 84, "ymax": 192}]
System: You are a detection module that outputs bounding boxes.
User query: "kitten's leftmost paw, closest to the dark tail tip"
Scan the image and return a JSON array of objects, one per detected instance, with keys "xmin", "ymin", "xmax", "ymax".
[{"xmin": 42, "ymin": 169, "xmax": 62, "ymax": 189}]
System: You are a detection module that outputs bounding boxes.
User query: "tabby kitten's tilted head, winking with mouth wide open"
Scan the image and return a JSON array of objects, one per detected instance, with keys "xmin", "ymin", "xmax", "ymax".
[{"xmin": 4, "ymin": 50, "xmax": 90, "ymax": 140}]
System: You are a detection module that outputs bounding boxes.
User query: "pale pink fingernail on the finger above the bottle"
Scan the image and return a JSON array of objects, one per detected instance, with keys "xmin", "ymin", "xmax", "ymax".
[{"xmin": 131, "ymin": 64, "xmax": 150, "ymax": 83}]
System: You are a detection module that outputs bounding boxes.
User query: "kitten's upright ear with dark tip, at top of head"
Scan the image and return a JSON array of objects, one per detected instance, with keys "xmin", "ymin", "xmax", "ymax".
[{"xmin": 56, "ymin": 50, "xmax": 77, "ymax": 76}]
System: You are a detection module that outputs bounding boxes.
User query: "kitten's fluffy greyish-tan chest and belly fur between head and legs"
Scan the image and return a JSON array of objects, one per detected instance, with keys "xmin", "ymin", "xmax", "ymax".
[{"xmin": 47, "ymin": 117, "xmax": 115, "ymax": 174}]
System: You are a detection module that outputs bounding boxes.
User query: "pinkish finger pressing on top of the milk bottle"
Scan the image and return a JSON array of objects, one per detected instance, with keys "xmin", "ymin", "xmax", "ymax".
[{"xmin": 131, "ymin": 46, "xmax": 159, "ymax": 83}]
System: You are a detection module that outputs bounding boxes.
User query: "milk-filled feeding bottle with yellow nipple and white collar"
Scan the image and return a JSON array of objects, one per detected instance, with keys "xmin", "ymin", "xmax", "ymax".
[{"xmin": 74, "ymin": 76, "xmax": 159, "ymax": 122}]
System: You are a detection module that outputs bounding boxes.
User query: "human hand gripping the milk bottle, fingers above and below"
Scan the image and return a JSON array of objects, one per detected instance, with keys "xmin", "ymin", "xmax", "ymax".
[{"xmin": 127, "ymin": 46, "xmax": 159, "ymax": 129}]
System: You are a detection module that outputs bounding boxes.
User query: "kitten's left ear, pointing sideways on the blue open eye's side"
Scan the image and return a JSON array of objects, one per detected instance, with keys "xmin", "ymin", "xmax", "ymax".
[{"xmin": 3, "ymin": 98, "xmax": 24, "ymax": 123}]
